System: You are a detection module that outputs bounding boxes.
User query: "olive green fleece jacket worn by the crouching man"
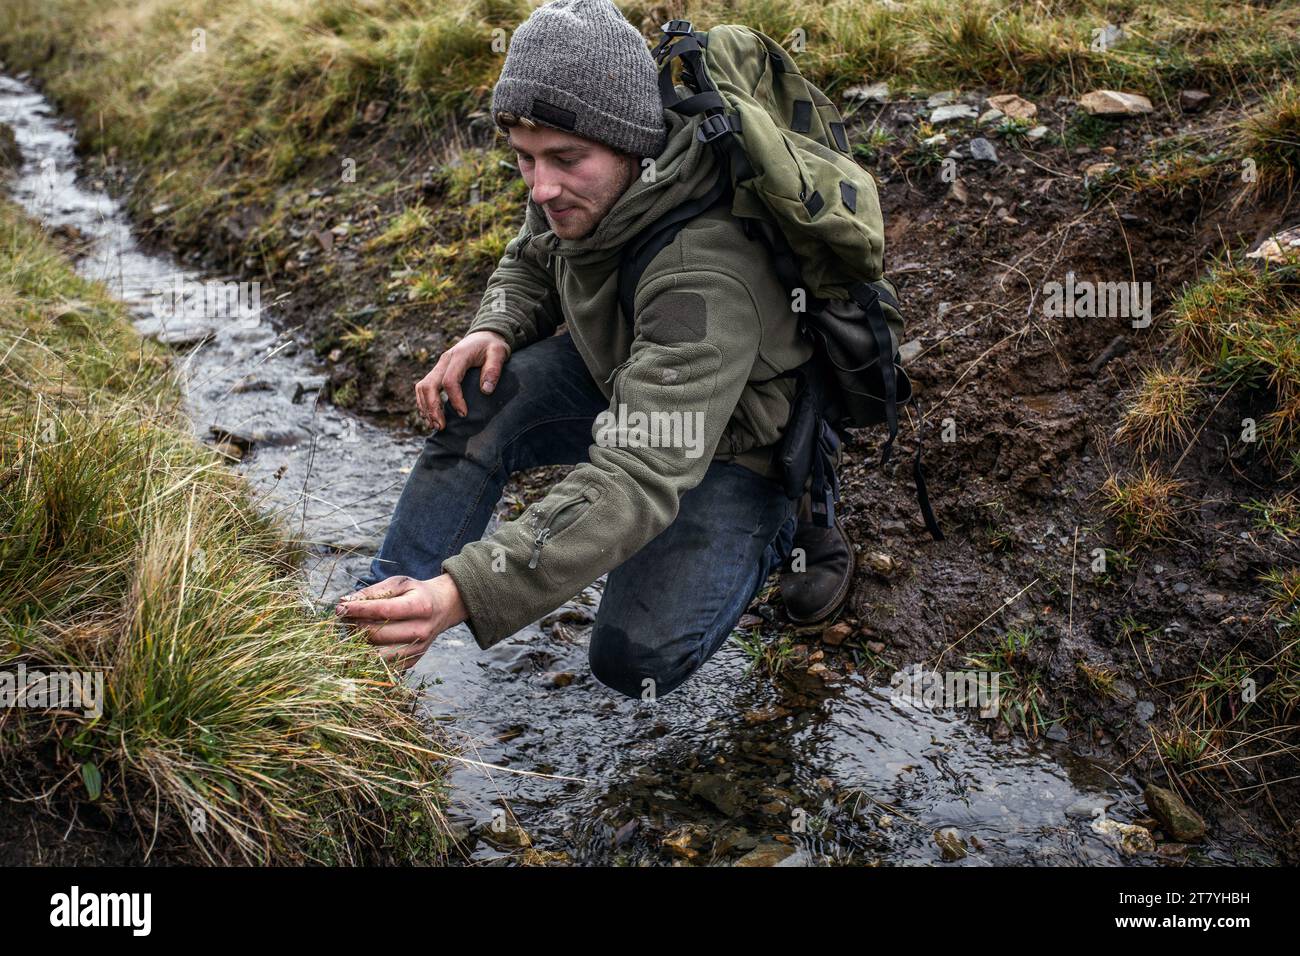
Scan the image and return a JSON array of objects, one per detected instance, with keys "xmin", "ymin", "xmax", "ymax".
[{"xmin": 442, "ymin": 111, "xmax": 811, "ymax": 648}]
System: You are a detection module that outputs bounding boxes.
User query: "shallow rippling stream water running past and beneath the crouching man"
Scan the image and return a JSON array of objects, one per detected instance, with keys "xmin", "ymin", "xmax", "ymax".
[{"xmin": 0, "ymin": 75, "xmax": 1258, "ymax": 866}]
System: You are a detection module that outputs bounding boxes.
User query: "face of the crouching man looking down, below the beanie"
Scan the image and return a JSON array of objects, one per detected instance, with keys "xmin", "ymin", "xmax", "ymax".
[{"xmin": 510, "ymin": 126, "xmax": 637, "ymax": 239}]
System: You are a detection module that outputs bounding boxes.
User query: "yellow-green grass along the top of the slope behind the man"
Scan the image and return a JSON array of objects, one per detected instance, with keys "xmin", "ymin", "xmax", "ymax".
[{"xmin": 0, "ymin": 0, "xmax": 1300, "ymax": 259}]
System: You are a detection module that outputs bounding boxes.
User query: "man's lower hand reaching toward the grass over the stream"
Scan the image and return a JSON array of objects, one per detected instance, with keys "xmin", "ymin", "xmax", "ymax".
[{"xmin": 334, "ymin": 575, "xmax": 469, "ymax": 670}]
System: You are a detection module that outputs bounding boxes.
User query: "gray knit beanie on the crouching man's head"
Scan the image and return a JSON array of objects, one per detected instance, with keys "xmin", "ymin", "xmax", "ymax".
[{"xmin": 489, "ymin": 0, "xmax": 668, "ymax": 156}]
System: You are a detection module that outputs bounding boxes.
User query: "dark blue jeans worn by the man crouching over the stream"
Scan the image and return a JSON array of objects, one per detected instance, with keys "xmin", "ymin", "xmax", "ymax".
[{"xmin": 367, "ymin": 334, "xmax": 797, "ymax": 697}]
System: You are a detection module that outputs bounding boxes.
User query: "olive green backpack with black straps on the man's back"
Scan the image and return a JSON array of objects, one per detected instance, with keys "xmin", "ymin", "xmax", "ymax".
[{"xmin": 619, "ymin": 20, "xmax": 943, "ymax": 540}]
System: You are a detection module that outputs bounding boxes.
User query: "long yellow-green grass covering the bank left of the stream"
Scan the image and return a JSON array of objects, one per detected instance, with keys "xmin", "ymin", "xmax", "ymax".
[{"xmin": 0, "ymin": 204, "xmax": 445, "ymax": 862}]
